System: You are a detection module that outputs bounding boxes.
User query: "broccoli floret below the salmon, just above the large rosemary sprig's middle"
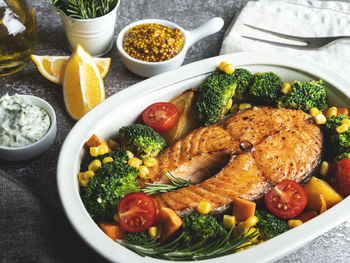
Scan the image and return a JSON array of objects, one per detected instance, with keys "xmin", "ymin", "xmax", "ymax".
[{"xmin": 183, "ymin": 213, "xmax": 227, "ymax": 240}]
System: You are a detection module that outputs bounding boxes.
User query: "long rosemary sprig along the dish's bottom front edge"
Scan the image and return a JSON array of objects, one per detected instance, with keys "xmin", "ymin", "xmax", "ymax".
[{"xmin": 117, "ymin": 227, "xmax": 259, "ymax": 261}]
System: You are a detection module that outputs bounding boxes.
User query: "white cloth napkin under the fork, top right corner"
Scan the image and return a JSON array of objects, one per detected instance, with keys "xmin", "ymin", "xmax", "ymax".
[{"xmin": 220, "ymin": 0, "xmax": 350, "ymax": 78}]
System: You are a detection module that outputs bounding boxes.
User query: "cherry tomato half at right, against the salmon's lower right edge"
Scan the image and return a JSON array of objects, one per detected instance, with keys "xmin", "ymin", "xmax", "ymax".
[{"xmin": 265, "ymin": 180, "xmax": 307, "ymax": 219}]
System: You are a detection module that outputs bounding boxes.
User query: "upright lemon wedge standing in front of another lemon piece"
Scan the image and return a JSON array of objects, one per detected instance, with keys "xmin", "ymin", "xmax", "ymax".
[{"xmin": 63, "ymin": 44, "xmax": 105, "ymax": 120}]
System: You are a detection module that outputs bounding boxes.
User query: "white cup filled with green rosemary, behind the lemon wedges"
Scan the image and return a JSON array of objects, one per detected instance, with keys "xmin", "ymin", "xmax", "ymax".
[{"xmin": 50, "ymin": 0, "xmax": 120, "ymax": 56}]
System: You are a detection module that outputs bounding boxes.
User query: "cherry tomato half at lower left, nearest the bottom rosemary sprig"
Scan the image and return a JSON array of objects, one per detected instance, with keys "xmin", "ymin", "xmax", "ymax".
[{"xmin": 117, "ymin": 192, "xmax": 157, "ymax": 232}]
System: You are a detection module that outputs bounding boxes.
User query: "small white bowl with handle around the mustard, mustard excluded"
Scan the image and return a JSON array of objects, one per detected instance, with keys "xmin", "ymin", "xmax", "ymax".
[{"xmin": 116, "ymin": 17, "xmax": 224, "ymax": 77}]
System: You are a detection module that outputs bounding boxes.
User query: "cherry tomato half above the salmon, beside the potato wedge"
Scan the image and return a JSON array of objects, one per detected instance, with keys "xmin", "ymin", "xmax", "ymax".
[{"xmin": 142, "ymin": 102, "xmax": 178, "ymax": 132}]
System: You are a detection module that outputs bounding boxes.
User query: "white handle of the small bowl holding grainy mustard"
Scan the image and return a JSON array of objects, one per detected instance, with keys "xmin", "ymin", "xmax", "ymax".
[{"xmin": 186, "ymin": 17, "xmax": 224, "ymax": 47}]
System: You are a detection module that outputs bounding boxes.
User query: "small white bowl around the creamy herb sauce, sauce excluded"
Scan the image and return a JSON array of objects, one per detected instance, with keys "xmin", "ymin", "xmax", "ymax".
[{"xmin": 0, "ymin": 95, "xmax": 57, "ymax": 161}]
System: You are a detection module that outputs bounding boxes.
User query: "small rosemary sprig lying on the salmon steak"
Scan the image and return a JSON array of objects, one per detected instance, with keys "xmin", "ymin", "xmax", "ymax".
[{"xmin": 142, "ymin": 171, "xmax": 193, "ymax": 195}]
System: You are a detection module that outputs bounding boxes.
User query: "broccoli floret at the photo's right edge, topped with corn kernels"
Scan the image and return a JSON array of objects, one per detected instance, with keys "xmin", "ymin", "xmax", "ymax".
[{"xmin": 325, "ymin": 114, "xmax": 350, "ymax": 158}]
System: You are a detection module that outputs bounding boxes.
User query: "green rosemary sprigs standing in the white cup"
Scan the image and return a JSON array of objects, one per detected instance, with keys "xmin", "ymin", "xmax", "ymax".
[{"xmin": 50, "ymin": 0, "xmax": 119, "ymax": 19}]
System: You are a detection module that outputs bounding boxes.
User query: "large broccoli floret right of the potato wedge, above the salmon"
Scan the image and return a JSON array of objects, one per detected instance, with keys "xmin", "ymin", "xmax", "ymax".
[{"xmin": 194, "ymin": 70, "xmax": 237, "ymax": 126}]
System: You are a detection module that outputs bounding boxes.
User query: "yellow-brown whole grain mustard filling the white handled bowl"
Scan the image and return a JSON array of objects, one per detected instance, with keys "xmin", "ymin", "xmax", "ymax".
[{"xmin": 123, "ymin": 23, "xmax": 185, "ymax": 62}]
